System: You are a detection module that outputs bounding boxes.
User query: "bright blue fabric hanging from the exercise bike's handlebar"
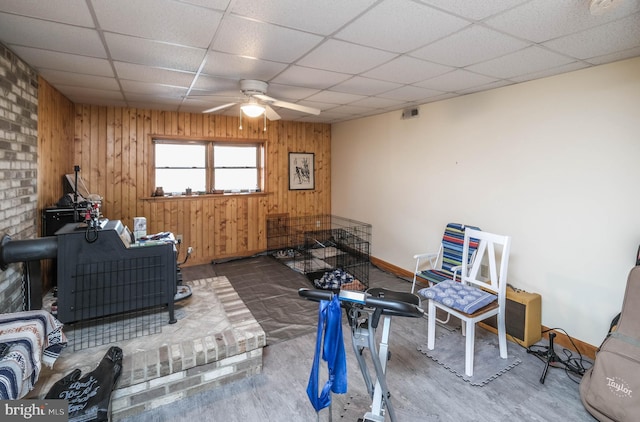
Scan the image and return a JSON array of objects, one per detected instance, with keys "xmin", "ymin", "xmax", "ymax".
[{"xmin": 307, "ymin": 295, "xmax": 347, "ymax": 412}]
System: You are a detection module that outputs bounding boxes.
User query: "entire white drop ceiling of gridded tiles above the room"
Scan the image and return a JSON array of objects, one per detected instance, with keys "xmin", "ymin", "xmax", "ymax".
[{"xmin": 0, "ymin": 0, "xmax": 640, "ymax": 123}]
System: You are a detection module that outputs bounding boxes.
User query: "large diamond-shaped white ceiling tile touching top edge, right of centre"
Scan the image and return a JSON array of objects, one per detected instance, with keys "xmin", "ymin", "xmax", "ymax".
[{"xmin": 335, "ymin": 0, "xmax": 470, "ymax": 53}]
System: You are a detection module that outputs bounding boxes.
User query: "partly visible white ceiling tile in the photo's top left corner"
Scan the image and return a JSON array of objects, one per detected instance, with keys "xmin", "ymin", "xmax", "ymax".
[{"xmin": 0, "ymin": 0, "xmax": 93, "ymax": 27}]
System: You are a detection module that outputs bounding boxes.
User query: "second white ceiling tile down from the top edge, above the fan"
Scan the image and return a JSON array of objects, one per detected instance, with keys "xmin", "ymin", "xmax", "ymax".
[{"xmin": 213, "ymin": 16, "xmax": 322, "ymax": 62}]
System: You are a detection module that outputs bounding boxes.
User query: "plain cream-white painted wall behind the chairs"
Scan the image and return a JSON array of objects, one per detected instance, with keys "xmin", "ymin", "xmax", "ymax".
[{"xmin": 331, "ymin": 58, "xmax": 640, "ymax": 346}]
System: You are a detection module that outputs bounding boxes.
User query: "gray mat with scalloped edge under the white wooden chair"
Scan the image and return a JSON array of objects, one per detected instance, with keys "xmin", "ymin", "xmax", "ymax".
[{"xmin": 418, "ymin": 324, "xmax": 522, "ymax": 386}]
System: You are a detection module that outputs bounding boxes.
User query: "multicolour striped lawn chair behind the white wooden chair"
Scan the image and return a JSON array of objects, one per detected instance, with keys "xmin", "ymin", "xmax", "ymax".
[{"xmin": 411, "ymin": 223, "xmax": 480, "ymax": 293}]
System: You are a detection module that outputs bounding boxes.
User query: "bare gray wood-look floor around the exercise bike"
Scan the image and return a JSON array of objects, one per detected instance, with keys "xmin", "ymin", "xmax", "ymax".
[{"xmin": 128, "ymin": 257, "xmax": 595, "ymax": 422}]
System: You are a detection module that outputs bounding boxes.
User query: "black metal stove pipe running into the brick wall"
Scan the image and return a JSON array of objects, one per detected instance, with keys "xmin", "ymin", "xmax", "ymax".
[{"xmin": 0, "ymin": 233, "xmax": 58, "ymax": 271}]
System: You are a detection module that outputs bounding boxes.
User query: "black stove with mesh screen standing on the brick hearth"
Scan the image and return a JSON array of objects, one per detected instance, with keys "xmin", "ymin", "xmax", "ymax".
[{"xmin": 56, "ymin": 220, "xmax": 177, "ymax": 323}]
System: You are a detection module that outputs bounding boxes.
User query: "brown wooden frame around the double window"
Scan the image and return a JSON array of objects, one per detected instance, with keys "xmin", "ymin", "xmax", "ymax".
[{"xmin": 149, "ymin": 135, "xmax": 267, "ymax": 196}]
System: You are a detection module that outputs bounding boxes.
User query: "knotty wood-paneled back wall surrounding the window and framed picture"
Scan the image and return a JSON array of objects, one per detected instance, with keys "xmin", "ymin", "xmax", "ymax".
[{"xmin": 71, "ymin": 105, "xmax": 331, "ymax": 264}]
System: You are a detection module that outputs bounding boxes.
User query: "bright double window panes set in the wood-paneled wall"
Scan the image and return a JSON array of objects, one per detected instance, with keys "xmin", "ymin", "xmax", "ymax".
[{"xmin": 154, "ymin": 139, "xmax": 264, "ymax": 195}]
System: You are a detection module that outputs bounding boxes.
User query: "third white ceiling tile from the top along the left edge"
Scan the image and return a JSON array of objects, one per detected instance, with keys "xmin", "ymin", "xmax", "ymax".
[{"xmin": 12, "ymin": 46, "xmax": 115, "ymax": 77}]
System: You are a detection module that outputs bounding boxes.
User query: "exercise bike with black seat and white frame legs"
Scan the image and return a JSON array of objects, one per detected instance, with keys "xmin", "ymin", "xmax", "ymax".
[{"xmin": 298, "ymin": 288, "xmax": 424, "ymax": 422}]
